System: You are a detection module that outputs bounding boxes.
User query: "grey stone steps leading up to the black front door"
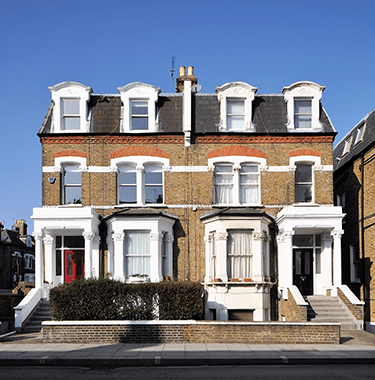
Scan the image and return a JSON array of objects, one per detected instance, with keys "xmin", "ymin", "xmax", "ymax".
[{"xmin": 306, "ymin": 296, "xmax": 361, "ymax": 330}]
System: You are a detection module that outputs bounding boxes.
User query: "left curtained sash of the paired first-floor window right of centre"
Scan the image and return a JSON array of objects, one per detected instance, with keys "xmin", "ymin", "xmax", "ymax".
[{"xmin": 214, "ymin": 164, "xmax": 233, "ymax": 204}]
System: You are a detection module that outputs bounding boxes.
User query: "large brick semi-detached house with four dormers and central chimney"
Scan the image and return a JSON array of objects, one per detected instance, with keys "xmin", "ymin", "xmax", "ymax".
[{"xmin": 16, "ymin": 67, "xmax": 354, "ymax": 321}]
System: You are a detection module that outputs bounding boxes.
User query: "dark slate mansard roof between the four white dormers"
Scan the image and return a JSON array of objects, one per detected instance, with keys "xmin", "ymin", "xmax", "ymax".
[{"xmin": 39, "ymin": 87, "xmax": 336, "ymax": 135}]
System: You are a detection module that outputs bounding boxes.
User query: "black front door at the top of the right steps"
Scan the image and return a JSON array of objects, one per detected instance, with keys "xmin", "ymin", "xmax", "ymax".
[{"xmin": 293, "ymin": 249, "xmax": 313, "ymax": 296}]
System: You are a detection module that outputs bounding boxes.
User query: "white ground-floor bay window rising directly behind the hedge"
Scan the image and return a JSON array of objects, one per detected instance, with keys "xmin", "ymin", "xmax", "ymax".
[{"xmin": 105, "ymin": 209, "xmax": 178, "ymax": 282}]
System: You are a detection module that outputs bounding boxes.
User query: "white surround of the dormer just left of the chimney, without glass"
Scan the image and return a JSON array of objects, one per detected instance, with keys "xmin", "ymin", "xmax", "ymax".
[{"xmin": 117, "ymin": 82, "xmax": 160, "ymax": 133}]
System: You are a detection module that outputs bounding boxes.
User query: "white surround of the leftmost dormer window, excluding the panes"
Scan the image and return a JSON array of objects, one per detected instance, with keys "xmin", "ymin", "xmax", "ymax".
[{"xmin": 48, "ymin": 82, "xmax": 92, "ymax": 133}]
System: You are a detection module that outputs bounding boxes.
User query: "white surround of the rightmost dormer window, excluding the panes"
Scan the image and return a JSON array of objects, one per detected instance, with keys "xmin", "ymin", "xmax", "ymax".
[{"xmin": 282, "ymin": 81, "xmax": 325, "ymax": 132}]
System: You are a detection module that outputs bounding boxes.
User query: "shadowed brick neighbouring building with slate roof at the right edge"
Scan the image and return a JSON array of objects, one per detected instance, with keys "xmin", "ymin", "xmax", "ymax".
[{"xmin": 333, "ymin": 110, "xmax": 375, "ymax": 333}]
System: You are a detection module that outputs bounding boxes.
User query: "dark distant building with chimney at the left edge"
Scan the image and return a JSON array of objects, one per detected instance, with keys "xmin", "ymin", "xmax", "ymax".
[{"xmin": 0, "ymin": 219, "xmax": 35, "ymax": 290}]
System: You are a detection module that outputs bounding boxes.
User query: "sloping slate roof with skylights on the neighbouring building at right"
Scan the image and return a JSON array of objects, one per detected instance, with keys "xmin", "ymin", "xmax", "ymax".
[{"xmin": 333, "ymin": 108, "xmax": 375, "ymax": 171}]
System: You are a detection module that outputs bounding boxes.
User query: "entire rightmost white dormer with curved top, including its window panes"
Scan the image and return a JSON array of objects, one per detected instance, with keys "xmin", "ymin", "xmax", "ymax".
[{"xmin": 282, "ymin": 82, "xmax": 325, "ymax": 132}]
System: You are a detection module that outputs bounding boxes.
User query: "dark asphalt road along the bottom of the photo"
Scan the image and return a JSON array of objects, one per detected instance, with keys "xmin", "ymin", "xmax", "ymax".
[{"xmin": 0, "ymin": 365, "xmax": 375, "ymax": 380}]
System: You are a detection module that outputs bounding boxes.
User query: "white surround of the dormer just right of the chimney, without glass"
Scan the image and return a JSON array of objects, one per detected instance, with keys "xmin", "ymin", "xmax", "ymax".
[{"xmin": 215, "ymin": 82, "xmax": 258, "ymax": 132}]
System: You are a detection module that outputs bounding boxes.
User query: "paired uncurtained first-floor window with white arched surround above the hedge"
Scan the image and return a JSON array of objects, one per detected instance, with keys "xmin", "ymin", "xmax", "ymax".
[{"xmin": 111, "ymin": 156, "xmax": 169, "ymax": 206}]
